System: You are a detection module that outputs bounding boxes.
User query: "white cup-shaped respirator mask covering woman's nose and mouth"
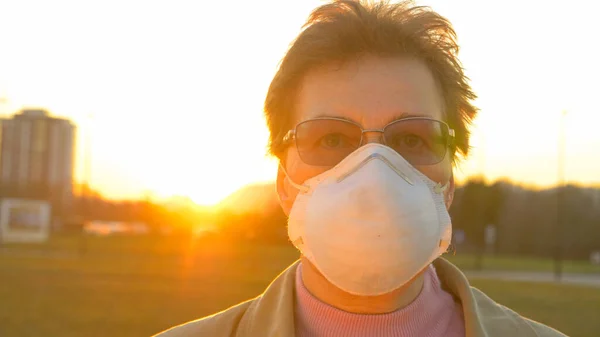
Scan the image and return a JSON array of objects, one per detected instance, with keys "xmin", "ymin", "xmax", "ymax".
[{"xmin": 288, "ymin": 144, "xmax": 452, "ymax": 296}]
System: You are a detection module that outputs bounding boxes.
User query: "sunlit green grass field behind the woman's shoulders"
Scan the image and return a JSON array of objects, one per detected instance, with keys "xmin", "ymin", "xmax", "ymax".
[{"xmin": 0, "ymin": 234, "xmax": 600, "ymax": 337}]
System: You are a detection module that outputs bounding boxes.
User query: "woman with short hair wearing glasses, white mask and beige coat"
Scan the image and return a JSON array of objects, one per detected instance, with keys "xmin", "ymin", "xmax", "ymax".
[{"xmin": 154, "ymin": 1, "xmax": 562, "ymax": 337}]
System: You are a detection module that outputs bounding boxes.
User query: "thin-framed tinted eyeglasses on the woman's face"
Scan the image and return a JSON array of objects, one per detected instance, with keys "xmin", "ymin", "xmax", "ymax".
[{"xmin": 283, "ymin": 117, "xmax": 454, "ymax": 166}]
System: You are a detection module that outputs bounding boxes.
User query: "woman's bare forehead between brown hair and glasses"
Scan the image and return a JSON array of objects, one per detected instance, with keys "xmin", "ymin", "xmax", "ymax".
[{"xmin": 294, "ymin": 57, "xmax": 444, "ymax": 128}]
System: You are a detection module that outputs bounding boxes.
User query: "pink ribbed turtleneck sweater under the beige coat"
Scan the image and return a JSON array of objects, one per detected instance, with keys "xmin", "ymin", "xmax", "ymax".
[{"xmin": 295, "ymin": 265, "xmax": 465, "ymax": 337}]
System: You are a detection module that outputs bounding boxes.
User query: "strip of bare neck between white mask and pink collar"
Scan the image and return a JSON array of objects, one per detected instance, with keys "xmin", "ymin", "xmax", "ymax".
[{"xmin": 302, "ymin": 257, "xmax": 424, "ymax": 314}]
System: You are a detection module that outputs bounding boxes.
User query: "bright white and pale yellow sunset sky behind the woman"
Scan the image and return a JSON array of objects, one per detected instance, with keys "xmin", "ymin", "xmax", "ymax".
[{"xmin": 0, "ymin": 0, "xmax": 600, "ymax": 204}]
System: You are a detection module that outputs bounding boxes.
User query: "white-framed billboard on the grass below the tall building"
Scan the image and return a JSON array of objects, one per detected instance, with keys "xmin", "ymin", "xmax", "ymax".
[{"xmin": 0, "ymin": 199, "xmax": 50, "ymax": 242}]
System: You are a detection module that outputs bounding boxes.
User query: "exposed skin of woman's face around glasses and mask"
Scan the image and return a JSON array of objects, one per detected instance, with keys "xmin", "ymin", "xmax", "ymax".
[{"xmin": 277, "ymin": 57, "xmax": 454, "ymax": 214}]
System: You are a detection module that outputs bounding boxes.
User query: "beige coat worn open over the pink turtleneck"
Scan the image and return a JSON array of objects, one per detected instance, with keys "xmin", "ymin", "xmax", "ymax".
[{"xmin": 156, "ymin": 258, "xmax": 564, "ymax": 337}]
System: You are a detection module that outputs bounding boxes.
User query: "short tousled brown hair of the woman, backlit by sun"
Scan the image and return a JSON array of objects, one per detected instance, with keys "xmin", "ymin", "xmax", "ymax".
[{"xmin": 264, "ymin": 0, "xmax": 477, "ymax": 158}]
